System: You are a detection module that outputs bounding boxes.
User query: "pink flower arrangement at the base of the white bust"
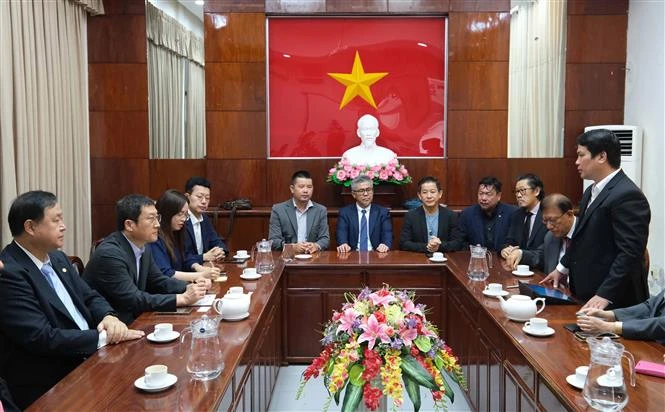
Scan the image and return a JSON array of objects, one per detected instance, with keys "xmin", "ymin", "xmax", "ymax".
[{"xmin": 326, "ymin": 158, "xmax": 411, "ymax": 187}]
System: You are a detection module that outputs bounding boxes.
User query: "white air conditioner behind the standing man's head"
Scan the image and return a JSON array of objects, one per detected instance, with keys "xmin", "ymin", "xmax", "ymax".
[{"xmin": 582, "ymin": 125, "xmax": 642, "ymax": 190}]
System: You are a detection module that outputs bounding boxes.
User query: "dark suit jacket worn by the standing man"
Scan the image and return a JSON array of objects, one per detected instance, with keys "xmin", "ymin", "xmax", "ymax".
[{"xmin": 561, "ymin": 171, "xmax": 651, "ymax": 308}]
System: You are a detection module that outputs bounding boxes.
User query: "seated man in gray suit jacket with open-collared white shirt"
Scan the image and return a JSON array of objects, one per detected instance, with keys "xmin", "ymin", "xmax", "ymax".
[{"xmin": 268, "ymin": 170, "xmax": 330, "ymax": 253}]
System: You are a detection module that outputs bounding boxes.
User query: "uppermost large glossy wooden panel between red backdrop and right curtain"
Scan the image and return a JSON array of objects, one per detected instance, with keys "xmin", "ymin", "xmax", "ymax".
[{"xmin": 448, "ymin": 13, "xmax": 510, "ymax": 61}]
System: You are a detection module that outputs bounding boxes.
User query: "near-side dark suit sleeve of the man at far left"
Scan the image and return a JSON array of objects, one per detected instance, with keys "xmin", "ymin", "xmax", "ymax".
[{"xmin": 0, "ymin": 266, "xmax": 99, "ymax": 357}]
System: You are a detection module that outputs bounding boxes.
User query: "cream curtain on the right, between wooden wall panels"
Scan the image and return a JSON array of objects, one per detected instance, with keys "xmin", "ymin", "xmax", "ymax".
[{"xmin": 508, "ymin": 0, "xmax": 566, "ymax": 157}]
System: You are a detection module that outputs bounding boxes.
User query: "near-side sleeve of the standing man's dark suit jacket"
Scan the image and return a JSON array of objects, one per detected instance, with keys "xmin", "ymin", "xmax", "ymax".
[{"xmin": 596, "ymin": 190, "xmax": 651, "ymax": 301}]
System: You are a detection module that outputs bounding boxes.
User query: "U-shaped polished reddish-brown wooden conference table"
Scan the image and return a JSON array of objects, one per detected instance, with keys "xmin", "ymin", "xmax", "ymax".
[{"xmin": 29, "ymin": 251, "xmax": 665, "ymax": 411}]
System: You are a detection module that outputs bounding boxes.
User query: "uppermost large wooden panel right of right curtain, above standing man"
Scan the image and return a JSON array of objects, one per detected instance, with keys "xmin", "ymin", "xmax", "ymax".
[{"xmin": 566, "ymin": 14, "xmax": 628, "ymax": 64}]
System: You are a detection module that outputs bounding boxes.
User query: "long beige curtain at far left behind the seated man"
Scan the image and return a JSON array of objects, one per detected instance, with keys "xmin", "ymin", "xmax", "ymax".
[{"xmin": 0, "ymin": 0, "xmax": 104, "ymax": 258}]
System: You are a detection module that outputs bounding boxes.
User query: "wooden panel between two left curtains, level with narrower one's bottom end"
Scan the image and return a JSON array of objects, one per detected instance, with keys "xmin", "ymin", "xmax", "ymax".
[{"xmin": 90, "ymin": 111, "xmax": 148, "ymax": 158}]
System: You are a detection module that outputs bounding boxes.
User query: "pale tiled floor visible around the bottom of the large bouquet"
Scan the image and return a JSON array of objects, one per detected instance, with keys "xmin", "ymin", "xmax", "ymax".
[{"xmin": 269, "ymin": 365, "xmax": 471, "ymax": 412}]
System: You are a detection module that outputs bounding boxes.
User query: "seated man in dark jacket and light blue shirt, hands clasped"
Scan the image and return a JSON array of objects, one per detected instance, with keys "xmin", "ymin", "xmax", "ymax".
[{"xmin": 399, "ymin": 176, "xmax": 464, "ymax": 253}]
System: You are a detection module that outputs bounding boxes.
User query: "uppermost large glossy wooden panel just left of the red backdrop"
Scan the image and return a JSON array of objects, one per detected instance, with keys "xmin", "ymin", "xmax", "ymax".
[{"xmin": 204, "ymin": 13, "xmax": 266, "ymax": 63}]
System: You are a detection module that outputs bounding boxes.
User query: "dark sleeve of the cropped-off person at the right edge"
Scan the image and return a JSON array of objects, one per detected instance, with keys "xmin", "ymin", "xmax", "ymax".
[{"xmin": 614, "ymin": 289, "xmax": 665, "ymax": 345}]
